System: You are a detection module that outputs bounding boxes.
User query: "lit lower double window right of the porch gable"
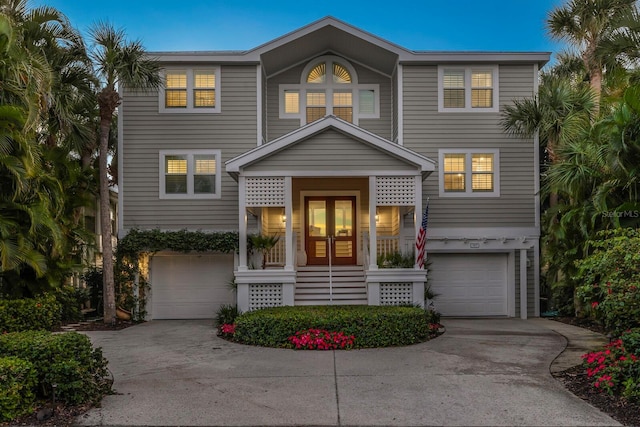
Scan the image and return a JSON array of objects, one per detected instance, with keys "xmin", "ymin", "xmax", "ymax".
[{"xmin": 439, "ymin": 149, "xmax": 500, "ymax": 197}]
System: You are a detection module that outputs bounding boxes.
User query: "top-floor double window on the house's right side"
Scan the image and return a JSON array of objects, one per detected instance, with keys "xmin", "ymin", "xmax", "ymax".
[{"xmin": 438, "ymin": 66, "xmax": 499, "ymax": 112}]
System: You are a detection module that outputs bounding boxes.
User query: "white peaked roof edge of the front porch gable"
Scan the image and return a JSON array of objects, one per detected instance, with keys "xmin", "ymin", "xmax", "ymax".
[{"xmin": 225, "ymin": 116, "xmax": 436, "ymax": 179}]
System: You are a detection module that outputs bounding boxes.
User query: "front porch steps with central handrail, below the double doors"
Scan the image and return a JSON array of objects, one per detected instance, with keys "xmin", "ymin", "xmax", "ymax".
[{"xmin": 295, "ymin": 266, "xmax": 367, "ymax": 305}]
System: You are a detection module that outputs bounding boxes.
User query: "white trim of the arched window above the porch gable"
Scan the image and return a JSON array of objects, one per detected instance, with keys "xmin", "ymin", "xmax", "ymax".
[{"xmin": 278, "ymin": 55, "xmax": 380, "ymax": 126}]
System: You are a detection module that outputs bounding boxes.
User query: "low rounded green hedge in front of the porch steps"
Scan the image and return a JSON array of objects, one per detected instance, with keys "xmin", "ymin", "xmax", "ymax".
[{"xmin": 233, "ymin": 305, "xmax": 439, "ymax": 348}]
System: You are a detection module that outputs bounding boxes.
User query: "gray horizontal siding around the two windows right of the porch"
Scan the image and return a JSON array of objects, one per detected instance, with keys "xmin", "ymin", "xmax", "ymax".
[{"xmin": 403, "ymin": 65, "xmax": 536, "ymax": 227}]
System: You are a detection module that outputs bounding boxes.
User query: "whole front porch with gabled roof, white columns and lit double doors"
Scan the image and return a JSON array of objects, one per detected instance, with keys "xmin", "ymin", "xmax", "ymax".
[{"xmin": 226, "ymin": 116, "xmax": 435, "ymax": 310}]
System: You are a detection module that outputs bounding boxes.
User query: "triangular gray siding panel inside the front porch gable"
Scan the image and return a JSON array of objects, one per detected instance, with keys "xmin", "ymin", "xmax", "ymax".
[{"xmin": 246, "ymin": 130, "xmax": 415, "ymax": 171}]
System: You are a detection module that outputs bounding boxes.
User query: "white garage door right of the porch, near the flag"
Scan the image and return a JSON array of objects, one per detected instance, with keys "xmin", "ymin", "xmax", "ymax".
[{"xmin": 427, "ymin": 253, "xmax": 508, "ymax": 316}]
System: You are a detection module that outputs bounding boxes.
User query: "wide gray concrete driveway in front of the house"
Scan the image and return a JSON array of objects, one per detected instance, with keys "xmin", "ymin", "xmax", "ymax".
[{"xmin": 77, "ymin": 319, "xmax": 619, "ymax": 426}]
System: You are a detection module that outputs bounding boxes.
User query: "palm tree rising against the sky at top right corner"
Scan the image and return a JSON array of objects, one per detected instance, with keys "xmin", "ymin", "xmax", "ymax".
[{"xmin": 547, "ymin": 0, "xmax": 637, "ymax": 115}]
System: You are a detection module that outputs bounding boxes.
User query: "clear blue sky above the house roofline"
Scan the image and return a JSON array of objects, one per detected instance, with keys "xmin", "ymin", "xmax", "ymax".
[{"xmin": 35, "ymin": 0, "xmax": 564, "ymax": 56}]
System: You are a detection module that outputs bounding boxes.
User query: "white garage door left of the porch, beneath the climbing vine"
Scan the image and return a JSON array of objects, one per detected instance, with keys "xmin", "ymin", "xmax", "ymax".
[{"xmin": 151, "ymin": 254, "xmax": 233, "ymax": 319}]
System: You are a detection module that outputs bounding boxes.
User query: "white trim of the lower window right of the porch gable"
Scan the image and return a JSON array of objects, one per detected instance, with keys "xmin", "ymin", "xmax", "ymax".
[{"xmin": 438, "ymin": 148, "xmax": 500, "ymax": 197}]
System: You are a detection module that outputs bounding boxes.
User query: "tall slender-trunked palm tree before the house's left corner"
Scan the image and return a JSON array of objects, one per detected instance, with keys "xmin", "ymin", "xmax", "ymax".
[{"xmin": 90, "ymin": 23, "xmax": 161, "ymax": 323}]
